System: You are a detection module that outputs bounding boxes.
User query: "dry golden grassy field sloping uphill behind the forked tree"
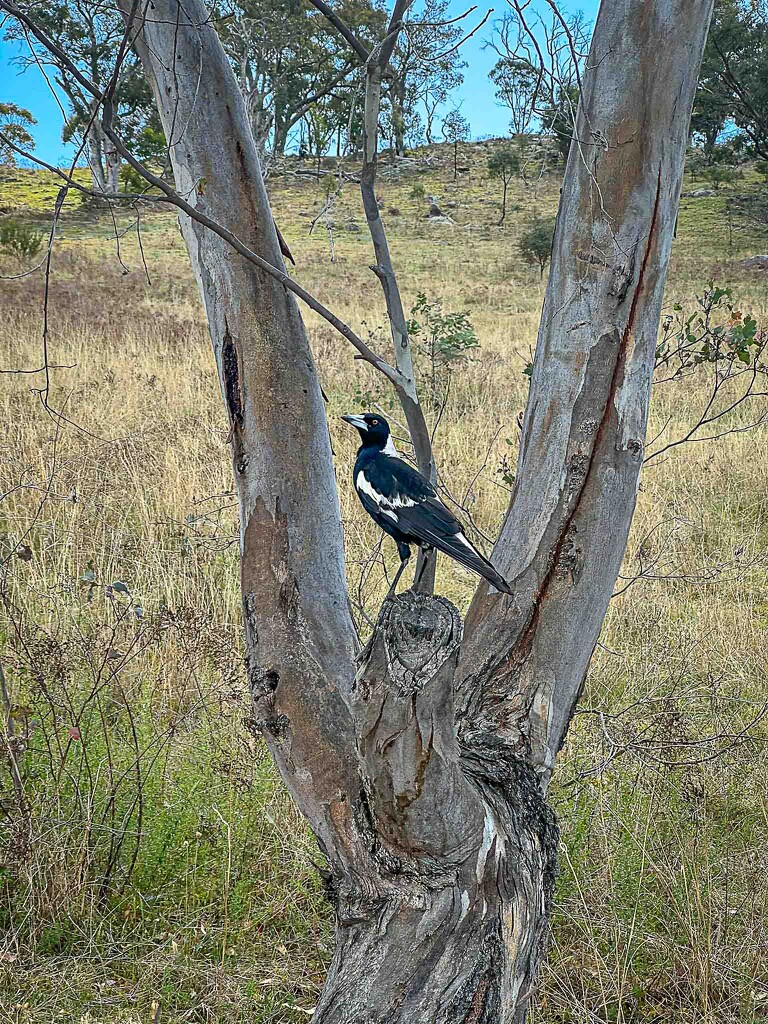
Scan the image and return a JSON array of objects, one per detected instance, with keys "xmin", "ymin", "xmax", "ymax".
[{"xmin": 0, "ymin": 144, "xmax": 768, "ymax": 1024}]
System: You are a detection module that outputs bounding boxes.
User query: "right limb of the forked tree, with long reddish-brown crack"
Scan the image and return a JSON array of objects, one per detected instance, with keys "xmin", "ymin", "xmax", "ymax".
[{"xmin": 457, "ymin": 0, "xmax": 712, "ymax": 788}]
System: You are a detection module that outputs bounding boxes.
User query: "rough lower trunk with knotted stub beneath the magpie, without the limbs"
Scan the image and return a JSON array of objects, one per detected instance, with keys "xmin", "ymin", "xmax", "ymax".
[{"xmin": 314, "ymin": 593, "xmax": 557, "ymax": 1024}]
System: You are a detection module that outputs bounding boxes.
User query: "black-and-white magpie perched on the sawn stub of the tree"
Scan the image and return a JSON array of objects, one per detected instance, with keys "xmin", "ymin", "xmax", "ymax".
[{"xmin": 342, "ymin": 413, "xmax": 512, "ymax": 597}]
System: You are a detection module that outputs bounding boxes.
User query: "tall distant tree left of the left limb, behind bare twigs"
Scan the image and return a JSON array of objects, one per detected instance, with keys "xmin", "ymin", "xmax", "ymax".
[{"xmin": 5, "ymin": 0, "xmax": 165, "ymax": 193}]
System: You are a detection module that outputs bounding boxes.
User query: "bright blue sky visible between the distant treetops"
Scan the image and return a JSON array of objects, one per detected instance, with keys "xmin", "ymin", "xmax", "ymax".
[{"xmin": 0, "ymin": 0, "xmax": 598, "ymax": 164}]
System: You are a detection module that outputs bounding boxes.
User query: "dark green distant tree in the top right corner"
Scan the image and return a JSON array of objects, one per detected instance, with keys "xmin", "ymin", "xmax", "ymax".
[{"xmin": 691, "ymin": 0, "xmax": 768, "ymax": 160}]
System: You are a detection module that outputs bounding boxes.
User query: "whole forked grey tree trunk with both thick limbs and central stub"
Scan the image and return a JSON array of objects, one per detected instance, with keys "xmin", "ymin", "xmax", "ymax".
[{"xmin": 121, "ymin": 0, "xmax": 712, "ymax": 1024}]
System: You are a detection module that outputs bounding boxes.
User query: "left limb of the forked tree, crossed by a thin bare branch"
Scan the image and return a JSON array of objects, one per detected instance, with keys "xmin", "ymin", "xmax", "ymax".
[{"xmin": 121, "ymin": 0, "xmax": 372, "ymax": 869}]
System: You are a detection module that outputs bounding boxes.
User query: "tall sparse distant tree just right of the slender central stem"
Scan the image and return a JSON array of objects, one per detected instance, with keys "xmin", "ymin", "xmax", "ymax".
[{"xmin": 386, "ymin": 0, "xmax": 467, "ymax": 154}]
